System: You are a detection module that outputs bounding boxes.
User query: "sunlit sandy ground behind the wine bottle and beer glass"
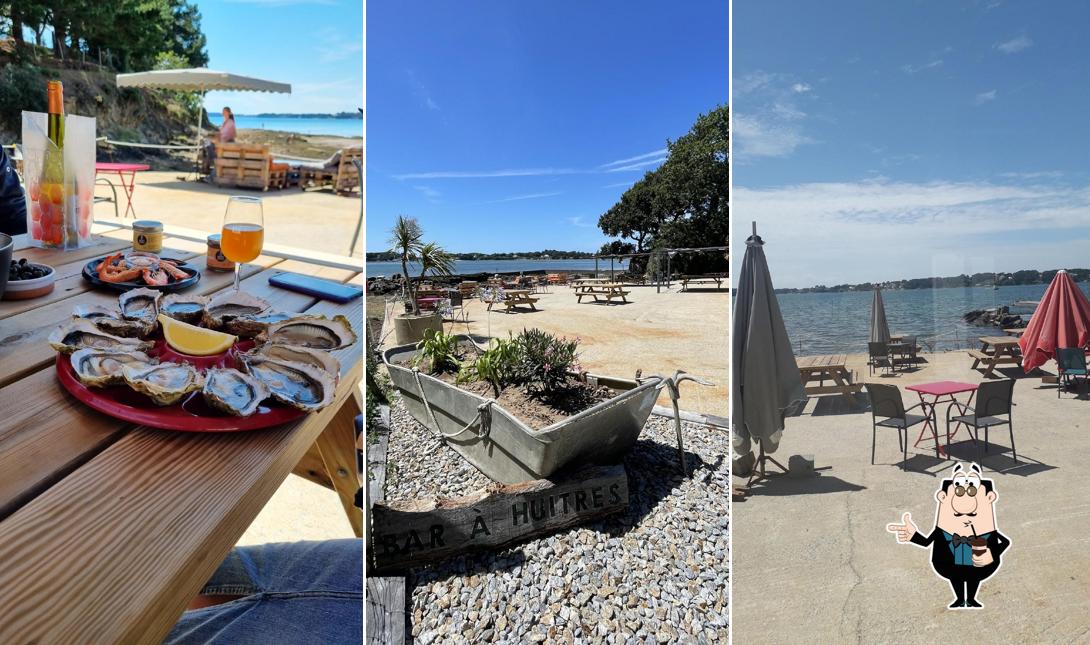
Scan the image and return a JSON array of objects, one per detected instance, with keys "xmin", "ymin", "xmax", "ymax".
[{"xmin": 95, "ymin": 171, "xmax": 363, "ymax": 257}]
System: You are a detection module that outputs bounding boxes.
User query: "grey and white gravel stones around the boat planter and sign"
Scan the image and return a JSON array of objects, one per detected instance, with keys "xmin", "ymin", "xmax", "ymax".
[{"xmin": 386, "ymin": 402, "xmax": 730, "ymax": 643}]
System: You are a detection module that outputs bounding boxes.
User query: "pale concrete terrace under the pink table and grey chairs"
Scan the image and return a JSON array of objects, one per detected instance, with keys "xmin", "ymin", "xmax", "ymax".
[{"xmin": 732, "ymin": 352, "xmax": 1090, "ymax": 644}]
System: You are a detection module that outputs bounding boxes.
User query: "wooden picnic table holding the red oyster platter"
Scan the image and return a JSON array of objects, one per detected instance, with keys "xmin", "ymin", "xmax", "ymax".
[{"xmin": 0, "ymin": 220, "xmax": 363, "ymax": 643}]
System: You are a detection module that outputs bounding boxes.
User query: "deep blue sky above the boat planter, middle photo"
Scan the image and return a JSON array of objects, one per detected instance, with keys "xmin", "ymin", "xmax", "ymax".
[{"xmin": 366, "ymin": 0, "xmax": 729, "ymax": 252}]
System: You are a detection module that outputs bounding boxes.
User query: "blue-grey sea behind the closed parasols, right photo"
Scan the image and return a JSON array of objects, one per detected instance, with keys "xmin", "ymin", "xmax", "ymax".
[{"xmin": 777, "ymin": 283, "xmax": 1087, "ymax": 356}]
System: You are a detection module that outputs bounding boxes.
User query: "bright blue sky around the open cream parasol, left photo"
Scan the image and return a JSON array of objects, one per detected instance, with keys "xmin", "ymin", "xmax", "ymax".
[{"xmin": 196, "ymin": 0, "xmax": 363, "ymax": 116}]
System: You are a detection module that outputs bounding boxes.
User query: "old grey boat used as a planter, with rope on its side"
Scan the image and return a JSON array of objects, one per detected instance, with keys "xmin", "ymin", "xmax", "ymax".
[{"xmin": 383, "ymin": 334, "xmax": 671, "ymax": 484}]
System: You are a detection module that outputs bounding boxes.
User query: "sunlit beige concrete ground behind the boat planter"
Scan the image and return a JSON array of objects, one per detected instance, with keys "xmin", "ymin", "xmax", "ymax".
[{"xmin": 447, "ymin": 285, "xmax": 730, "ymax": 417}]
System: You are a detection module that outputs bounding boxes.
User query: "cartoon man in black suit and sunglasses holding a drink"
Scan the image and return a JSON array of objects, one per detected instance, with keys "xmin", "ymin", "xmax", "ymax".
[{"xmin": 886, "ymin": 463, "xmax": 1010, "ymax": 609}]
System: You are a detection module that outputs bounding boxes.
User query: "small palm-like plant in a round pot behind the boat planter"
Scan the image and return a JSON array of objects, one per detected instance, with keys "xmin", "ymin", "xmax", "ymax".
[{"xmin": 390, "ymin": 215, "xmax": 455, "ymax": 344}]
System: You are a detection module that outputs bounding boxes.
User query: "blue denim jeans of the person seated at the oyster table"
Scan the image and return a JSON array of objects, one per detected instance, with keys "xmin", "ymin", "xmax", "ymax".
[{"xmin": 164, "ymin": 539, "xmax": 363, "ymax": 645}]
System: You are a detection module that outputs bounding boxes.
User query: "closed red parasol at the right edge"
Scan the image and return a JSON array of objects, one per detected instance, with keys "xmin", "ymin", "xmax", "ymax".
[{"xmin": 1018, "ymin": 270, "xmax": 1090, "ymax": 374}]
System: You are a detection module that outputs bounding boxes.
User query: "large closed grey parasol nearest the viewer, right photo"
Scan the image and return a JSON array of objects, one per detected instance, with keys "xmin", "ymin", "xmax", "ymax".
[{"xmin": 730, "ymin": 224, "xmax": 807, "ymax": 474}]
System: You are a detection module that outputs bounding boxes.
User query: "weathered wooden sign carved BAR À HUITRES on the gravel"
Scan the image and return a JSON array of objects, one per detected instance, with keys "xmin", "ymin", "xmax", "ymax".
[{"xmin": 370, "ymin": 465, "xmax": 628, "ymax": 570}]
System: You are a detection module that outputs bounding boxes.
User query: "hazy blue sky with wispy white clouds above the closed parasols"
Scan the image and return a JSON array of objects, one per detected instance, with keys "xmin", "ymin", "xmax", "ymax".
[{"xmin": 731, "ymin": 0, "xmax": 1090, "ymax": 287}]
